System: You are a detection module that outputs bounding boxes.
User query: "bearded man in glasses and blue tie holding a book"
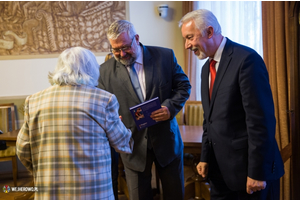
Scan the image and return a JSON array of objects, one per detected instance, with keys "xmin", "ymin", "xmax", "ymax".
[{"xmin": 99, "ymin": 20, "xmax": 191, "ymax": 200}]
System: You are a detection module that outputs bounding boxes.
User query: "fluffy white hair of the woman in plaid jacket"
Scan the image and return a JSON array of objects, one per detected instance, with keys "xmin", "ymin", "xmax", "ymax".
[{"xmin": 48, "ymin": 47, "xmax": 100, "ymax": 86}]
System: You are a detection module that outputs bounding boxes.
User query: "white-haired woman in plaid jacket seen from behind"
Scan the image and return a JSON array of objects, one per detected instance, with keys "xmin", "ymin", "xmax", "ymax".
[{"xmin": 17, "ymin": 47, "xmax": 133, "ymax": 200}]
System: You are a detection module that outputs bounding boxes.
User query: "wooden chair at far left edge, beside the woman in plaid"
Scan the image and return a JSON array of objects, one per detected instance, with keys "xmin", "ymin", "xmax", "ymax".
[{"xmin": 0, "ymin": 103, "xmax": 18, "ymax": 187}]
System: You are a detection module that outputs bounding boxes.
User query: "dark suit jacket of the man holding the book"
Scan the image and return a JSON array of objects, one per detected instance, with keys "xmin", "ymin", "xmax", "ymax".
[{"xmin": 98, "ymin": 44, "xmax": 191, "ymax": 171}]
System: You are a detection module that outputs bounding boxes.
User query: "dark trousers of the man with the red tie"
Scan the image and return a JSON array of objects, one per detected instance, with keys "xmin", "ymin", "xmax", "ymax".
[{"xmin": 209, "ymin": 149, "xmax": 280, "ymax": 200}]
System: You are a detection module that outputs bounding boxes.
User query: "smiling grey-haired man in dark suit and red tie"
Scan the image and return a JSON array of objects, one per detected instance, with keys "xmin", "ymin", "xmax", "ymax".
[{"xmin": 180, "ymin": 9, "xmax": 284, "ymax": 200}]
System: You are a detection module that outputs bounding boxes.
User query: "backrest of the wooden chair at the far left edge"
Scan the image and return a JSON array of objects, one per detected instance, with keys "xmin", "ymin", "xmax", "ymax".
[{"xmin": 0, "ymin": 103, "xmax": 17, "ymax": 132}]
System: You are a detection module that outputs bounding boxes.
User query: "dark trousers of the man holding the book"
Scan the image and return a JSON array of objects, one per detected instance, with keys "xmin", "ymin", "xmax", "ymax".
[{"xmin": 124, "ymin": 148, "xmax": 184, "ymax": 200}]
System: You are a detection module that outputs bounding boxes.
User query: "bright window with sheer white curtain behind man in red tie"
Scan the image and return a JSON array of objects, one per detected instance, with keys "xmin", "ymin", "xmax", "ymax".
[{"xmin": 196, "ymin": 1, "xmax": 263, "ymax": 101}]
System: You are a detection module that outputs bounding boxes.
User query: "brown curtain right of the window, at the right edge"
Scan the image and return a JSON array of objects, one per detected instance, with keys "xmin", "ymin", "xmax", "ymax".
[{"xmin": 262, "ymin": 1, "xmax": 291, "ymax": 200}]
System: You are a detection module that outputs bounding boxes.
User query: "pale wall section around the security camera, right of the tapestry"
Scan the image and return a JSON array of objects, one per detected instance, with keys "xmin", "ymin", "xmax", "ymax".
[{"xmin": 129, "ymin": 1, "xmax": 184, "ymax": 66}]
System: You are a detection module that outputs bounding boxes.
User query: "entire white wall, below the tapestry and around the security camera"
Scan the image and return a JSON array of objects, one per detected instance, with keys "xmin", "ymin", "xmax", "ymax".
[{"xmin": 0, "ymin": 1, "xmax": 184, "ymax": 98}]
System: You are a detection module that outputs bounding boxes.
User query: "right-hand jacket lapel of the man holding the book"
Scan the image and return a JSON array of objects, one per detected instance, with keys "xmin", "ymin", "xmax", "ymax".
[{"xmin": 141, "ymin": 44, "xmax": 154, "ymax": 100}]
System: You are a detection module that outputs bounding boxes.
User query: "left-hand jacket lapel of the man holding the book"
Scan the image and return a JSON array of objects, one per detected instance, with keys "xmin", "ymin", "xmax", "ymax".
[{"xmin": 116, "ymin": 62, "xmax": 141, "ymax": 103}]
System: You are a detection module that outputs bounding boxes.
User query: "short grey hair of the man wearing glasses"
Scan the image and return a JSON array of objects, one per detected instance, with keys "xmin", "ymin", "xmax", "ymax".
[{"xmin": 106, "ymin": 20, "xmax": 136, "ymax": 40}]
